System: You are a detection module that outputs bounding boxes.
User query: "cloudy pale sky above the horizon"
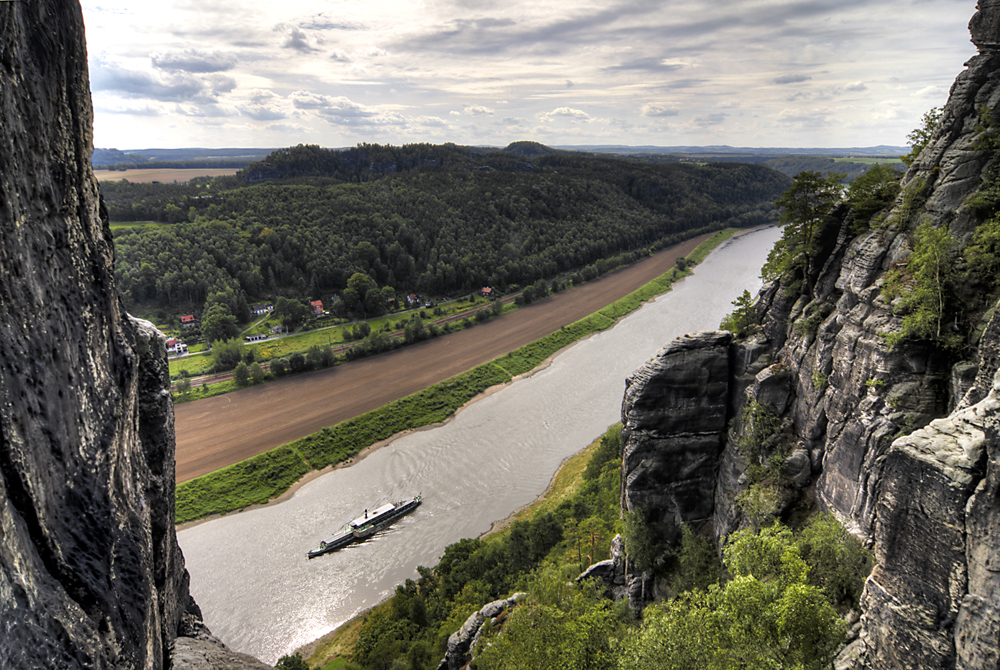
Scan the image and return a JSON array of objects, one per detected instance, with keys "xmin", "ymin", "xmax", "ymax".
[{"xmin": 82, "ymin": 0, "xmax": 976, "ymax": 150}]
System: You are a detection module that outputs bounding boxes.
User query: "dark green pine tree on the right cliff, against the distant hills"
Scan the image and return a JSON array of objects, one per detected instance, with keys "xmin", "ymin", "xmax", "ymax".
[{"xmin": 761, "ymin": 171, "xmax": 844, "ymax": 297}]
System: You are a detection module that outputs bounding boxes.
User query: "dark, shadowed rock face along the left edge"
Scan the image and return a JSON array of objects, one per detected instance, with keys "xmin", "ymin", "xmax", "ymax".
[{"xmin": 0, "ymin": 0, "xmax": 241, "ymax": 669}]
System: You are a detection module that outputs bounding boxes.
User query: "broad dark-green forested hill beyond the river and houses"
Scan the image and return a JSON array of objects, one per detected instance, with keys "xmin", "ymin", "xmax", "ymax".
[{"xmin": 101, "ymin": 143, "xmax": 790, "ymax": 318}]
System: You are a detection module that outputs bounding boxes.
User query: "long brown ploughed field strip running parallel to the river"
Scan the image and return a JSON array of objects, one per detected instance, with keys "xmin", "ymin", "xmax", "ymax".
[{"xmin": 175, "ymin": 235, "xmax": 709, "ymax": 482}]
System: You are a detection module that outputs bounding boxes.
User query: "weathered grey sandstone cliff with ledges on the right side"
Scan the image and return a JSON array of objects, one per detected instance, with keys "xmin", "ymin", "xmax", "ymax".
[{"xmin": 622, "ymin": 0, "xmax": 1000, "ymax": 669}]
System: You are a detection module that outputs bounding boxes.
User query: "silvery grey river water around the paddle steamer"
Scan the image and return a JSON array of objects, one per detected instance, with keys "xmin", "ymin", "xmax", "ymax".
[{"xmin": 178, "ymin": 228, "xmax": 780, "ymax": 663}]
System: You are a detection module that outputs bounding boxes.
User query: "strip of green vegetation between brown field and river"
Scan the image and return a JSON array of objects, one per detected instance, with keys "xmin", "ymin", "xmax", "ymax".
[{"xmin": 175, "ymin": 228, "xmax": 749, "ymax": 526}]
